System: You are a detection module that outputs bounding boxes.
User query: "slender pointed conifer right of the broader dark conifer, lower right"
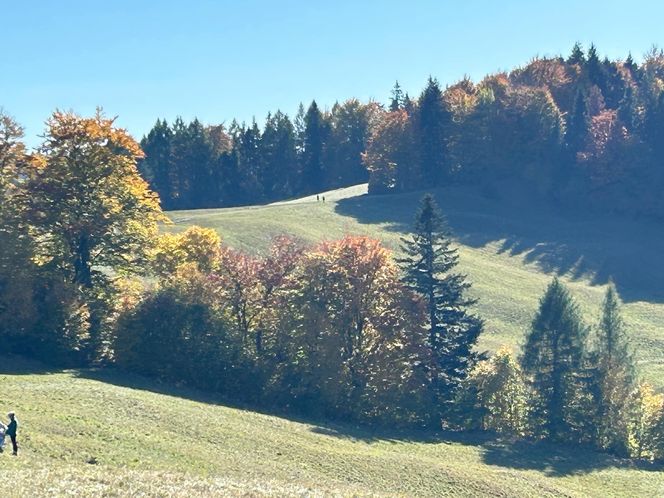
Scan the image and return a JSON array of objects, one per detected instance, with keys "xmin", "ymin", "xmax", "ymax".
[{"xmin": 595, "ymin": 282, "xmax": 636, "ymax": 454}]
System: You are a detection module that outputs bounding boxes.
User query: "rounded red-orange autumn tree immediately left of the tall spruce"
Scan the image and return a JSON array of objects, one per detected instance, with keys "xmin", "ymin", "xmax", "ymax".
[{"xmin": 282, "ymin": 236, "xmax": 424, "ymax": 420}]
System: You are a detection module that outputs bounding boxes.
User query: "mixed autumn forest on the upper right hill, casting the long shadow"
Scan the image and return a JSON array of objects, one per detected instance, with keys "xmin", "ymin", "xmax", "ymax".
[{"xmin": 363, "ymin": 44, "xmax": 664, "ymax": 217}]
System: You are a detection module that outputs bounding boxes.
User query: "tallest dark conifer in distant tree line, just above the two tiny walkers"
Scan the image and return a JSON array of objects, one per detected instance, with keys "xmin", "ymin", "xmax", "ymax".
[{"xmin": 301, "ymin": 100, "xmax": 329, "ymax": 192}]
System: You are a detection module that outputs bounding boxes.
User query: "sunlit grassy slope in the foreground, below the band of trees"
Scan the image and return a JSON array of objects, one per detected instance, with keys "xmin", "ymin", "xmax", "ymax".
[{"xmin": 0, "ymin": 357, "xmax": 664, "ymax": 497}]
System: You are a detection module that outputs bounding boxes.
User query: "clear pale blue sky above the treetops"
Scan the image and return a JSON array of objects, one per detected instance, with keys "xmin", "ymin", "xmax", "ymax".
[{"xmin": 5, "ymin": 0, "xmax": 664, "ymax": 145}]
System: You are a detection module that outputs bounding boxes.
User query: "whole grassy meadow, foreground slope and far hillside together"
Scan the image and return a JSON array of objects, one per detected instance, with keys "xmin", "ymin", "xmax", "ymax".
[{"xmin": 5, "ymin": 186, "xmax": 664, "ymax": 497}]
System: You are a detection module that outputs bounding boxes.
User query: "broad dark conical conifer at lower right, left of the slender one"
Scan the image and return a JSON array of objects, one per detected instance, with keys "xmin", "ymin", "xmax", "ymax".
[{"xmin": 521, "ymin": 278, "xmax": 590, "ymax": 441}]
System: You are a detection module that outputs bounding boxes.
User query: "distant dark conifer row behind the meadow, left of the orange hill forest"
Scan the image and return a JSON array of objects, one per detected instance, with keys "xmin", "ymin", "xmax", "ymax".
[{"xmin": 139, "ymin": 99, "xmax": 380, "ymax": 209}]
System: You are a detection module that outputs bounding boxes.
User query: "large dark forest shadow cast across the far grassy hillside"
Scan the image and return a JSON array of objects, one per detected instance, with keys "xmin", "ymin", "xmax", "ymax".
[{"xmin": 335, "ymin": 186, "xmax": 664, "ymax": 303}]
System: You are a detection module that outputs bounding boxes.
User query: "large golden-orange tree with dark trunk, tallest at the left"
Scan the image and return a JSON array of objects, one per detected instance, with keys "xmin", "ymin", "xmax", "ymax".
[{"xmin": 23, "ymin": 111, "xmax": 162, "ymax": 356}]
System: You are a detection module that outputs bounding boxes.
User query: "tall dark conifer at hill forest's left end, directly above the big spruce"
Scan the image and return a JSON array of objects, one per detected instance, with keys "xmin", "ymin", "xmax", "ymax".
[{"xmin": 415, "ymin": 77, "xmax": 451, "ymax": 187}]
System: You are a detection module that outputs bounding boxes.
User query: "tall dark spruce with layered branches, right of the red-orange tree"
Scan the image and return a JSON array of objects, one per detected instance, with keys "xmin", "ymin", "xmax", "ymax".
[{"xmin": 399, "ymin": 195, "xmax": 483, "ymax": 417}]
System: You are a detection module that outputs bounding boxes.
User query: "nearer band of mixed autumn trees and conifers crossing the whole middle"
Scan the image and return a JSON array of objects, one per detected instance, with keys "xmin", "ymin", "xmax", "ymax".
[{"xmin": 0, "ymin": 106, "xmax": 664, "ymax": 459}]
